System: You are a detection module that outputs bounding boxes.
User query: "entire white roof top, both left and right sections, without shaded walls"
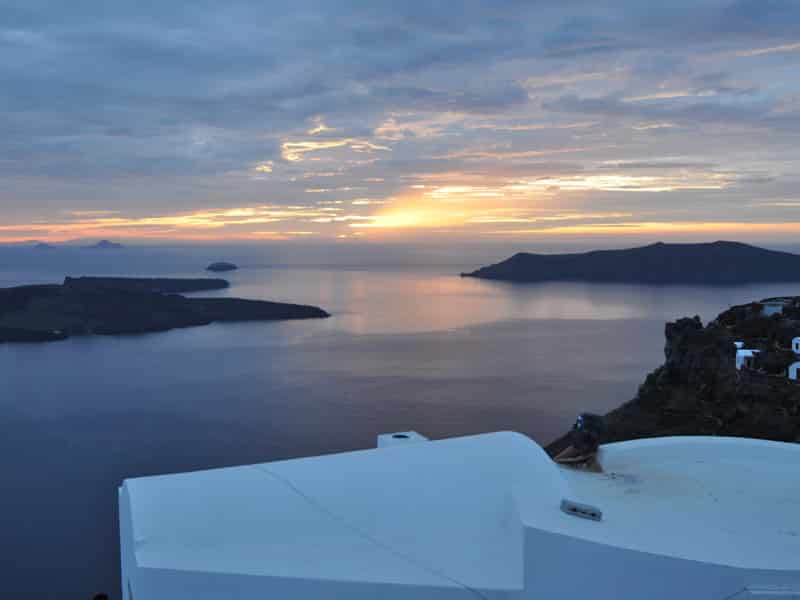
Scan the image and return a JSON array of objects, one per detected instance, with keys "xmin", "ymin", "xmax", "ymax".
[{"xmin": 124, "ymin": 432, "xmax": 800, "ymax": 590}]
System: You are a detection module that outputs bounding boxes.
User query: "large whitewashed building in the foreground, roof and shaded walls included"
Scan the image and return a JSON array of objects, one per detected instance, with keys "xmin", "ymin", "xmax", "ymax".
[{"xmin": 119, "ymin": 432, "xmax": 800, "ymax": 600}]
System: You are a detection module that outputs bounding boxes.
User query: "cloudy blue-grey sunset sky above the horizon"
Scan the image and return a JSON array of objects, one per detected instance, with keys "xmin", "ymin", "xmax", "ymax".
[{"xmin": 0, "ymin": 0, "xmax": 800, "ymax": 243}]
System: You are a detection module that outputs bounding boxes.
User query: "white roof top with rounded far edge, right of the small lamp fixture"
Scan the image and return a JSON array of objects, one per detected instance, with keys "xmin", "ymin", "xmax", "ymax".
[{"xmin": 548, "ymin": 437, "xmax": 800, "ymax": 572}]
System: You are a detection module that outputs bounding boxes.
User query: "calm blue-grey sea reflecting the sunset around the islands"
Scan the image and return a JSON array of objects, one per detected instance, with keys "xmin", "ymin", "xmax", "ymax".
[{"xmin": 0, "ymin": 245, "xmax": 797, "ymax": 600}]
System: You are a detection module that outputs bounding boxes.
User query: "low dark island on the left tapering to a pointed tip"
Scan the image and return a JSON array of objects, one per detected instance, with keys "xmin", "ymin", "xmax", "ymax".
[{"xmin": 0, "ymin": 277, "xmax": 330, "ymax": 343}]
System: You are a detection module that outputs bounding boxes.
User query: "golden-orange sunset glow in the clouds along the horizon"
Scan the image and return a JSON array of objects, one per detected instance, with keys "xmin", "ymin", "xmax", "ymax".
[{"xmin": 0, "ymin": 166, "xmax": 788, "ymax": 242}]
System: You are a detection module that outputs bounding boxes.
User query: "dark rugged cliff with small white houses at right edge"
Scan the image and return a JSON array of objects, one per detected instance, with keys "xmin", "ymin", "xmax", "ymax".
[{"xmin": 547, "ymin": 304, "xmax": 800, "ymax": 454}]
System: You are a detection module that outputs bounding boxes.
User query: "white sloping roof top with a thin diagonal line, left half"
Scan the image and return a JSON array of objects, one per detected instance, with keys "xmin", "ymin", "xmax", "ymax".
[{"xmin": 125, "ymin": 433, "xmax": 564, "ymax": 589}]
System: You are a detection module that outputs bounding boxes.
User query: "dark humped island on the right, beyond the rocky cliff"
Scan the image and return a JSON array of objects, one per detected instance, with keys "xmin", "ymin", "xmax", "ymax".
[{"xmin": 461, "ymin": 241, "xmax": 800, "ymax": 285}]
